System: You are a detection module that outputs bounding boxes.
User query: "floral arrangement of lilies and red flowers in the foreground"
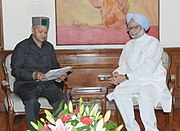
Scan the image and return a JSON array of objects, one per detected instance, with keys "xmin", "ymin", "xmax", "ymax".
[{"xmin": 31, "ymin": 98, "xmax": 123, "ymax": 131}]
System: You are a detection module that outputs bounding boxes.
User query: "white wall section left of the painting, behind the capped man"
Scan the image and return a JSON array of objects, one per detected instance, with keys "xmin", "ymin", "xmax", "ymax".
[{"xmin": 2, "ymin": 0, "xmax": 56, "ymax": 50}]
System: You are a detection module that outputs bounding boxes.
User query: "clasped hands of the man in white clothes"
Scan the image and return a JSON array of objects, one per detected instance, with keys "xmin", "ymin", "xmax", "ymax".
[{"xmin": 111, "ymin": 72, "xmax": 127, "ymax": 85}]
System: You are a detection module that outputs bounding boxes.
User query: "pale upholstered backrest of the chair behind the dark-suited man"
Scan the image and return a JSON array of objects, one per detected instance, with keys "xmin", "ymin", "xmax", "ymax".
[{"xmin": 3, "ymin": 54, "xmax": 15, "ymax": 92}]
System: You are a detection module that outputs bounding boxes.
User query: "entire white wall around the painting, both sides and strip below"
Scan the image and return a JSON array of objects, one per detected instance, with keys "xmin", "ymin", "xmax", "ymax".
[{"xmin": 2, "ymin": 0, "xmax": 180, "ymax": 50}]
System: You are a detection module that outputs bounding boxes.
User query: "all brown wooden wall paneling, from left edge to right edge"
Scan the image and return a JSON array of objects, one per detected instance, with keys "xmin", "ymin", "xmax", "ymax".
[{"xmin": 0, "ymin": 48, "xmax": 180, "ymax": 111}]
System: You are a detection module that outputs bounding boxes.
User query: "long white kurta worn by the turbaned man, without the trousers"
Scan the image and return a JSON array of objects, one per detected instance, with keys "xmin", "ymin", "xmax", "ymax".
[{"xmin": 107, "ymin": 34, "xmax": 172, "ymax": 112}]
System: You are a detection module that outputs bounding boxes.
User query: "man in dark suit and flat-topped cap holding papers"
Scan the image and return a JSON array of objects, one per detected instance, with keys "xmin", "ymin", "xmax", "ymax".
[{"xmin": 11, "ymin": 17, "xmax": 67, "ymax": 131}]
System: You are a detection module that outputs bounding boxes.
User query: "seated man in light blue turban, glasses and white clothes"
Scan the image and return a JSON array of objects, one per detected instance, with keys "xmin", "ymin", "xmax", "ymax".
[{"xmin": 107, "ymin": 13, "xmax": 172, "ymax": 131}]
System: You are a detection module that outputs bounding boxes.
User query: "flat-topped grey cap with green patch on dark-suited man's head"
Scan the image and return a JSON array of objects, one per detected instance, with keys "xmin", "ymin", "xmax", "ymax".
[{"xmin": 32, "ymin": 17, "xmax": 49, "ymax": 27}]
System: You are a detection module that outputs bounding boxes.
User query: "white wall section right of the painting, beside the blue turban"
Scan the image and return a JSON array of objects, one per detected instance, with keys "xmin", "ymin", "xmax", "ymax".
[{"xmin": 160, "ymin": 0, "xmax": 180, "ymax": 47}]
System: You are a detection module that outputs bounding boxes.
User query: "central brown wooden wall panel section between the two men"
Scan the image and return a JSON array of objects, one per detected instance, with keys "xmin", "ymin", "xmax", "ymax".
[{"xmin": 57, "ymin": 49, "xmax": 121, "ymax": 88}]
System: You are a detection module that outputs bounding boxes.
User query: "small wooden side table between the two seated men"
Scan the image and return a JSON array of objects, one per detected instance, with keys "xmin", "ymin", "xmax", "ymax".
[{"xmin": 70, "ymin": 87, "xmax": 107, "ymax": 115}]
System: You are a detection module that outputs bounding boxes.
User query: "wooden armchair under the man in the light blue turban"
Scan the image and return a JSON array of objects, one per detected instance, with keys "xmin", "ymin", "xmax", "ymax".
[{"xmin": 110, "ymin": 51, "xmax": 175, "ymax": 131}]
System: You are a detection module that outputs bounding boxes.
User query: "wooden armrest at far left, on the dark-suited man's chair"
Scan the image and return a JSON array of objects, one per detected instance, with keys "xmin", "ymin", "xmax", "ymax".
[{"xmin": 1, "ymin": 80, "xmax": 14, "ymax": 110}]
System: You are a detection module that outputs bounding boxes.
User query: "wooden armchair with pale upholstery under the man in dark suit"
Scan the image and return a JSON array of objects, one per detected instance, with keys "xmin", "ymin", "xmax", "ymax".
[{"xmin": 2, "ymin": 54, "xmax": 67, "ymax": 131}]
